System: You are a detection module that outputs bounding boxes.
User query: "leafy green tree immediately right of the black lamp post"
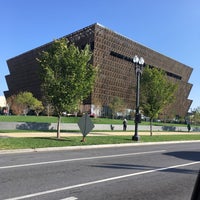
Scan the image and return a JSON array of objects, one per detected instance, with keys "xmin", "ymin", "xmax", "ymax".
[{"xmin": 141, "ymin": 66, "xmax": 177, "ymax": 136}]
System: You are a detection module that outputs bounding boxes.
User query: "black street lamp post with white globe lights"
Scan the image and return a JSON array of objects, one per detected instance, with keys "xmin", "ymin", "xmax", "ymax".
[{"xmin": 132, "ymin": 55, "xmax": 144, "ymax": 141}]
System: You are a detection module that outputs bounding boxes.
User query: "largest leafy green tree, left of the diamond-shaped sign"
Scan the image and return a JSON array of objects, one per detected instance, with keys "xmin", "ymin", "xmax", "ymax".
[{"xmin": 37, "ymin": 38, "xmax": 97, "ymax": 138}]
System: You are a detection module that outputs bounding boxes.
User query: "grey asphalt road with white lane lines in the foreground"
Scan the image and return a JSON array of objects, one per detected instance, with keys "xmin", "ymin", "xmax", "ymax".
[{"xmin": 0, "ymin": 142, "xmax": 200, "ymax": 200}]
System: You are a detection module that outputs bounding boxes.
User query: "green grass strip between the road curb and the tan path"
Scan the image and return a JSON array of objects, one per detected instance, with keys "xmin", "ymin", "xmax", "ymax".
[{"xmin": 0, "ymin": 134, "xmax": 200, "ymax": 150}]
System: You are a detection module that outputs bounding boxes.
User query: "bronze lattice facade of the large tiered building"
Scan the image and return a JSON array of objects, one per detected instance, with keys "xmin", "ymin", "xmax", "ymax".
[{"xmin": 4, "ymin": 24, "xmax": 193, "ymax": 116}]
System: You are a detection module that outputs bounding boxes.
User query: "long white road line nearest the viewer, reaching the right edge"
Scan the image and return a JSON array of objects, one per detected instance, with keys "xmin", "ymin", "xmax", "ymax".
[{"xmin": 4, "ymin": 161, "xmax": 200, "ymax": 200}]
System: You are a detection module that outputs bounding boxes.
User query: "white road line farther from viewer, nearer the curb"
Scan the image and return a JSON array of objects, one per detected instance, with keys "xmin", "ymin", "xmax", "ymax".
[{"xmin": 0, "ymin": 150, "xmax": 166, "ymax": 169}]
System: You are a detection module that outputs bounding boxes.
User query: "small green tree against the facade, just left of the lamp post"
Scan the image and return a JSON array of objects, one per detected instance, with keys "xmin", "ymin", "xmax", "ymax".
[{"xmin": 109, "ymin": 97, "xmax": 125, "ymax": 118}]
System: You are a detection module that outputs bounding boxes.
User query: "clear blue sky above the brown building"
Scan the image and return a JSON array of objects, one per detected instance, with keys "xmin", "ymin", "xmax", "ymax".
[{"xmin": 0, "ymin": 0, "xmax": 200, "ymax": 108}]
